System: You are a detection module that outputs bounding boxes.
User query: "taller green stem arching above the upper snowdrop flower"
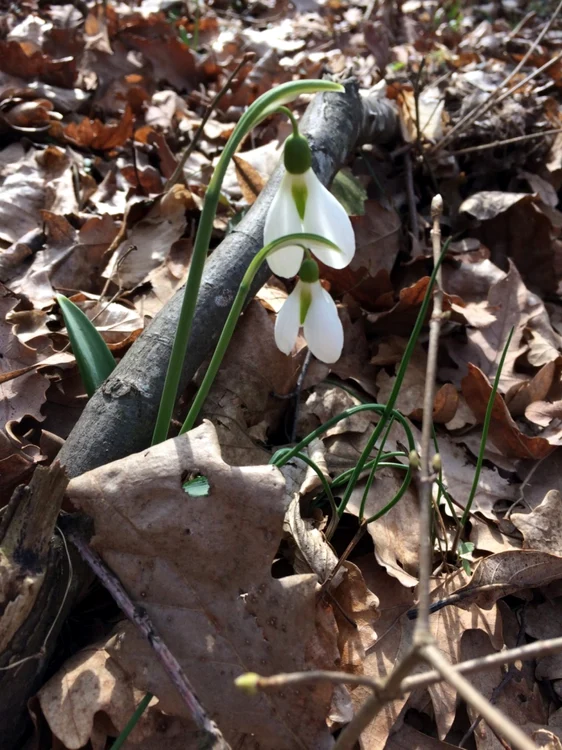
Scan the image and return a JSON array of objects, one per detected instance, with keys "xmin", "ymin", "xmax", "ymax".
[{"xmin": 152, "ymin": 81, "xmax": 344, "ymax": 445}]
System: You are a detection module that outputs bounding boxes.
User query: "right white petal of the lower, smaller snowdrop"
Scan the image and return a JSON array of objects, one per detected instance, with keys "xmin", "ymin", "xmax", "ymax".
[{"xmin": 304, "ymin": 281, "xmax": 343, "ymax": 364}]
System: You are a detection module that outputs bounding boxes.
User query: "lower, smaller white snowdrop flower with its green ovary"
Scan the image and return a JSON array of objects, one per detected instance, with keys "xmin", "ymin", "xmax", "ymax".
[{"xmin": 275, "ymin": 259, "xmax": 343, "ymax": 364}]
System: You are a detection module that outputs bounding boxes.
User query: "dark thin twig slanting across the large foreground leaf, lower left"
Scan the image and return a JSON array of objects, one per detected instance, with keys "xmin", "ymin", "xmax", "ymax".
[{"xmin": 67, "ymin": 523, "xmax": 230, "ymax": 750}]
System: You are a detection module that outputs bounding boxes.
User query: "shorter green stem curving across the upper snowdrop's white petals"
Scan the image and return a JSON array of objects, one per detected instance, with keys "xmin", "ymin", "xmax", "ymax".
[{"xmin": 180, "ymin": 234, "xmax": 338, "ymax": 435}]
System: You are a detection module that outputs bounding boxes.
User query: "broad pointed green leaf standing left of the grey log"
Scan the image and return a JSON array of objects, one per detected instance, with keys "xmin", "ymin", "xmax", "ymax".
[{"xmin": 57, "ymin": 294, "xmax": 116, "ymax": 396}]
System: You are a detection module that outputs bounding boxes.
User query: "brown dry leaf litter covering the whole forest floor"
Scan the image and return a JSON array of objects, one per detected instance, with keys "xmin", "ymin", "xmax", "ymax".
[{"xmin": 0, "ymin": 0, "xmax": 562, "ymax": 750}]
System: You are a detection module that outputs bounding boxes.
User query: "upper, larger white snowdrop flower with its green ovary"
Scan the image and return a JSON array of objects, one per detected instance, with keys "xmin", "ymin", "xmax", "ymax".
[{"xmin": 264, "ymin": 133, "xmax": 355, "ymax": 278}]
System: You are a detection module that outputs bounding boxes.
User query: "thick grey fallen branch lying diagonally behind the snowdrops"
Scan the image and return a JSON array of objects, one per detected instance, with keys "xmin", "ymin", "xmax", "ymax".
[{"xmin": 60, "ymin": 81, "xmax": 396, "ymax": 477}]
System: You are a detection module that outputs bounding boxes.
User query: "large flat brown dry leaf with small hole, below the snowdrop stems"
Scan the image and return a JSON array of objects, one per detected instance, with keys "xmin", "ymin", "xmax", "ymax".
[{"xmin": 65, "ymin": 422, "xmax": 337, "ymax": 750}]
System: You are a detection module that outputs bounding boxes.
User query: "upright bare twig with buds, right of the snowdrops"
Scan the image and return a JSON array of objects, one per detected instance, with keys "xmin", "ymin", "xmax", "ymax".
[{"xmin": 414, "ymin": 195, "xmax": 443, "ymax": 643}]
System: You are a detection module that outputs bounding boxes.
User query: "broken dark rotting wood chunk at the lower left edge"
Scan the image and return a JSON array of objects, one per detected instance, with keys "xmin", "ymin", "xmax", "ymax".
[{"xmin": 0, "ymin": 462, "xmax": 84, "ymax": 750}]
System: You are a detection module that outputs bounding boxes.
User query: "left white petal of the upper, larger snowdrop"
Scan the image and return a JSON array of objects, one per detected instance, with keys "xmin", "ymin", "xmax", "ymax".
[{"xmin": 263, "ymin": 174, "xmax": 303, "ymax": 279}]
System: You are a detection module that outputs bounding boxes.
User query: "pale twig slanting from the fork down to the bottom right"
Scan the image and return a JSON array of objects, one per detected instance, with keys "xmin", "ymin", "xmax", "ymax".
[{"xmin": 421, "ymin": 644, "xmax": 537, "ymax": 750}]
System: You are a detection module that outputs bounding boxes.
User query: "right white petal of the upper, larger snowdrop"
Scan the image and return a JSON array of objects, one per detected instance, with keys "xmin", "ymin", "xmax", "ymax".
[{"xmin": 303, "ymin": 169, "xmax": 355, "ymax": 268}]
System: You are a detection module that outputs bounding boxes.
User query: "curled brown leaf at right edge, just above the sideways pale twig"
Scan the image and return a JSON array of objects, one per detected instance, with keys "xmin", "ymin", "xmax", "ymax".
[{"xmin": 454, "ymin": 550, "xmax": 562, "ymax": 609}]
